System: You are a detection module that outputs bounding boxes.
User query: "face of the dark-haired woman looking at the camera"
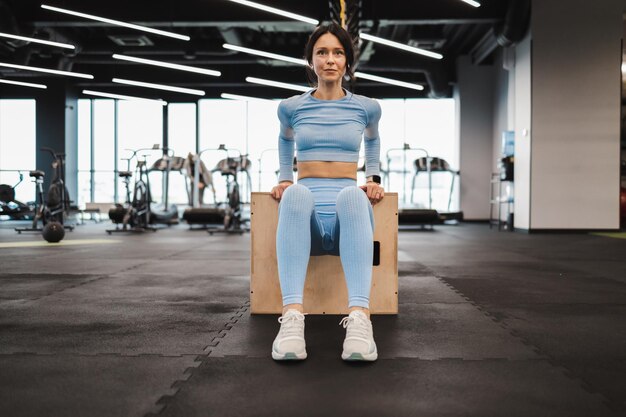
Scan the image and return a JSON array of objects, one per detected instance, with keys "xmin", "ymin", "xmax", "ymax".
[{"xmin": 312, "ymin": 33, "xmax": 346, "ymax": 84}]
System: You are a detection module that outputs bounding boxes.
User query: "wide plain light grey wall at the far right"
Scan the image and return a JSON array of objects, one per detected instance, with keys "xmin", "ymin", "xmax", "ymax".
[{"xmin": 531, "ymin": 0, "xmax": 622, "ymax": 229}]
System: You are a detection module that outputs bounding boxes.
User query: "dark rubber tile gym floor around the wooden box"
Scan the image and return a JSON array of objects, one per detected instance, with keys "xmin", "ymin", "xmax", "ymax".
[{"xmin": 0, "ymin": 219, "xmax": 626, "ymax": 417}]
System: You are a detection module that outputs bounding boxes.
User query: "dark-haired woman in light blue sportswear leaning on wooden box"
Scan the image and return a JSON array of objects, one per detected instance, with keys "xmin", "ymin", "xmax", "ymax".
[{"xmin": 271, "ymin": 24, "xmax": 384, "ymax": 361}]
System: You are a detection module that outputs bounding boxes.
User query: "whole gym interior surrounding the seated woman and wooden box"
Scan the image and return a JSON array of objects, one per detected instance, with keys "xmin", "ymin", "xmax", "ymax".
[{"xmin": 0, "ymin": 0, "xmax": 626, "ymax": 416}]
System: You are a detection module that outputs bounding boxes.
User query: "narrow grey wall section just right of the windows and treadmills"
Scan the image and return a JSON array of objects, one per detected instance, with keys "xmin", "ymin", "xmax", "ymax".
[{"xmin": 455, "ymin": 56, "xmax": 494, "ymax": 220}]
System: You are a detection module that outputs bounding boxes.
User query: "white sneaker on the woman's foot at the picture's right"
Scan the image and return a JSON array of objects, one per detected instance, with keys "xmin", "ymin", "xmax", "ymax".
[{"xmin": 339, "ymin": 310, "xmax": 378, "ymax": 361}]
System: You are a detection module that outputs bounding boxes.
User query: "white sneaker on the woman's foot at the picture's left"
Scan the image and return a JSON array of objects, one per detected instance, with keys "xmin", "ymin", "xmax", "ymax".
[{"xmin": 272, "ymin": 309, "xmax": 306, "ymax": 361}]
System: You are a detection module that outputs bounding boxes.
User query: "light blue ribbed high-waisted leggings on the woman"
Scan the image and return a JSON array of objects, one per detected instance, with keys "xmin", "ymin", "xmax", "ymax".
[{"xmin": 276, "ymin": 178, "xmax": 374, "ymax": 308}]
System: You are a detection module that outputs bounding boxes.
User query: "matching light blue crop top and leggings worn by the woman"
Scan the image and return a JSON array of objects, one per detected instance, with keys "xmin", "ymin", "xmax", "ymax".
[{"xmin": 276, "ymin": 90, "xmax": 381, "ymax": 308}]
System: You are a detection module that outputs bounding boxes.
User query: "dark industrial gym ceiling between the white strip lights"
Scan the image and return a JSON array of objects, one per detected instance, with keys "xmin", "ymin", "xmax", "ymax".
[{"xmin": 0, "ymin": 0, "xmax": 515, "ymax": 101}]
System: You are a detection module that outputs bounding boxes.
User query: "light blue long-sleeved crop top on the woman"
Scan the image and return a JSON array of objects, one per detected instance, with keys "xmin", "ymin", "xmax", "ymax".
[{"xmin": 278, "ymin": 90, "xmax": 381, "ymax": 182}]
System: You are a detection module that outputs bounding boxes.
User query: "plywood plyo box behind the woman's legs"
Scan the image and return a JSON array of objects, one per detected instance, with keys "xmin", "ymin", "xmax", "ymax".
[{"xmin": 250, "ymin": 192, "xmax": 398, "ymax": 314}]
